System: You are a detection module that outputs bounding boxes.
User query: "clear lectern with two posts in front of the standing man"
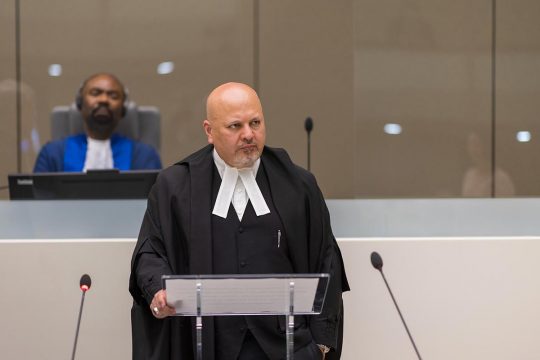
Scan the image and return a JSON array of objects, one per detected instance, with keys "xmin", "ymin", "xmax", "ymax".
[{"xmin": 162, "ymin": 274, "xmax": 330, "ymax": 360}]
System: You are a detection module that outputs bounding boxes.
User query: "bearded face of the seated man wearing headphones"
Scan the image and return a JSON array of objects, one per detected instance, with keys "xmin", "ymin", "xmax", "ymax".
[{"xmin": 81, "ymin": 75, "xmax": 125, "ymax": 140}]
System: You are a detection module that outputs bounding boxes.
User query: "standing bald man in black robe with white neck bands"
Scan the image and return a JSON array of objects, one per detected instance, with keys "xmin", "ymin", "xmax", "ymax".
[{"xmin": 129, "ymin": 83, "xmax": 349, "ymax": 360}]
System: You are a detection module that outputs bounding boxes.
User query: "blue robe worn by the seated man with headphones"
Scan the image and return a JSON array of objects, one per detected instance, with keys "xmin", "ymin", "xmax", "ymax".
[{"xmin": 34, "ymin": 134, "xmax": 161, "ymax": 172}]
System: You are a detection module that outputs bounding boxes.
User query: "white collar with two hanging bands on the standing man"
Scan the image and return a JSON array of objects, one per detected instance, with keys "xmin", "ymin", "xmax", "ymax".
[{"xmin": 212, "ymin": 149, "xmax": 270, "ymax": 219}]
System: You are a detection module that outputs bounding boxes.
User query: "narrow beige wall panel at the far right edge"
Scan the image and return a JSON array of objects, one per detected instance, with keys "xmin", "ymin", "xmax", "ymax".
[{"xmin": 495, "ymin": 0, "xmax": 540, "ymax": 196}]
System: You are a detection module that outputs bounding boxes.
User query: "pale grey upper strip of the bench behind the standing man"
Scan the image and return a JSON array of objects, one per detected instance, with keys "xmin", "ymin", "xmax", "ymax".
[{"xmin": 4, "ymin": 199, "xmax": 540, "ymax": 239}]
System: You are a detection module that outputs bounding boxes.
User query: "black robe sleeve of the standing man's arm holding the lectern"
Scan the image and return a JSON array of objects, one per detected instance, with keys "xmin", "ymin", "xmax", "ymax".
[{"xmin": 129, "ymin": 167, "xmax": 193, "ymax": 360}]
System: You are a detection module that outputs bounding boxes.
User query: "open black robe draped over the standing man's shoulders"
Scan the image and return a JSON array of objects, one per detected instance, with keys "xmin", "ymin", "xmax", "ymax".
[{"xmin": 129, "ymin": 145, "xmax": 349, "ymax": 360}]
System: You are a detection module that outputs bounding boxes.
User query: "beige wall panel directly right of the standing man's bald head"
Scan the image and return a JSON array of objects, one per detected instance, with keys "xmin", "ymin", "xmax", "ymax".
[{"xmin": 259, "ymin": 0, "xmax": 355, "ymax": 198}]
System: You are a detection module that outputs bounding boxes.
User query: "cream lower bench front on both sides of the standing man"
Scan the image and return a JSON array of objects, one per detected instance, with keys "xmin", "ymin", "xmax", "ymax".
[{"xmin": 4, "ymin": 236, "xmax": 540, "ymax": 360}]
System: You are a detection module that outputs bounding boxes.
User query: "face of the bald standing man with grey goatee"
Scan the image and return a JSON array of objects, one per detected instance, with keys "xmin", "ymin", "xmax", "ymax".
[{"xmin": 203, "ymin": 87, "xmax": 266, "ymax": 169}]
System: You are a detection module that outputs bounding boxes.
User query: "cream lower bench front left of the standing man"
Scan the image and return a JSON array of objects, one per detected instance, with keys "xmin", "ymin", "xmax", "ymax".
[{"xmin": 0, "ymin": 239, "xmax": 135, "ymax": 360}]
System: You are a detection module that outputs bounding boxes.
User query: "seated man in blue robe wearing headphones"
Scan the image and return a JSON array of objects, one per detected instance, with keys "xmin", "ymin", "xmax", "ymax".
[{"xmin": 34, "ymin": 73, "xmax": 161, "ymax": 172}]
